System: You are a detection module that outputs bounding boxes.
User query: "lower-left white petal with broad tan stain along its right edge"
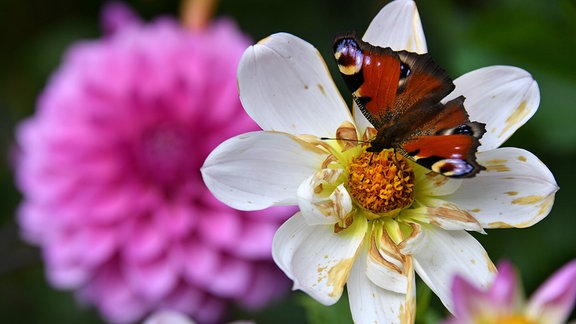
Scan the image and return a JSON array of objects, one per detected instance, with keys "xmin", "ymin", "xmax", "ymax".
[{"xmin": 272, "ymin": 213, "xmax": 368, "ymax": 305}]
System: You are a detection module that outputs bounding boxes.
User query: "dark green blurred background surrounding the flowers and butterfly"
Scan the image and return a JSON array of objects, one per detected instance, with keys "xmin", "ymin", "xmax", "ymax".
[{"xmin": 0, "ymin": 0, "xmax": 576, "ymax": 323}]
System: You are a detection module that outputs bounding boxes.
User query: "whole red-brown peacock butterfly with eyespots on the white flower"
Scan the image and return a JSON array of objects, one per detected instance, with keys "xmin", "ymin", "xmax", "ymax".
[{"xmin": 333, "ymin": 34, "xmax": 486, "ymax": 178}]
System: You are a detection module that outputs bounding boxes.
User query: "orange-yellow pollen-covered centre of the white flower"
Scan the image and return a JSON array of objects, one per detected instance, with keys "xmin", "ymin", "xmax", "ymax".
[{"xmin": 348, "ymin": 150, "xmax": 414, "ymax": 216}]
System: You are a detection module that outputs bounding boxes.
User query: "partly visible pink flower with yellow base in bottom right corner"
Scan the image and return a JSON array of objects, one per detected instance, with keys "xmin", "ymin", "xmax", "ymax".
[{"xmin": 445, "ymin": 260, "xmax": 576, "ymax": 324}]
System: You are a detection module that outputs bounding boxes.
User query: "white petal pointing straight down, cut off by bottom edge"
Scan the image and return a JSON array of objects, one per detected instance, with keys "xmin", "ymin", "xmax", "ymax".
[{"xmin": 347, "ymin": 247, "xmax": 415, "ymax": 324}]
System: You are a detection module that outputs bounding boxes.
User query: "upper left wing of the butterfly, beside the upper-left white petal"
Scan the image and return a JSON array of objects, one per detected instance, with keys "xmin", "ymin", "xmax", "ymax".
[{"xmin": 334, "ymin": 34, "xmax": 454, "ymax": 132}]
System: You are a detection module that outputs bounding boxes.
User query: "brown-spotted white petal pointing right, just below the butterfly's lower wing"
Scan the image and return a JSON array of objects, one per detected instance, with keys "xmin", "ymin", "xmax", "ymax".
[{"xmin": 444, "ymin": 147, "xmax": 558, "ymax": 228}]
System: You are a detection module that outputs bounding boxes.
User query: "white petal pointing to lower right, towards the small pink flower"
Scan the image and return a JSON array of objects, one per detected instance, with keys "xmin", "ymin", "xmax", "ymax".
[{"xmin": 406, "ymin": 227, "xmax": 496, "ymax": 312}]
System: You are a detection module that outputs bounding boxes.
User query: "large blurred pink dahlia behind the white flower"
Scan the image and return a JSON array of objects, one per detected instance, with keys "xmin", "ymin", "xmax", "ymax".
[{"xmin": 16, "ymin": 5, "xmax": 289, "ymax": 322}]
